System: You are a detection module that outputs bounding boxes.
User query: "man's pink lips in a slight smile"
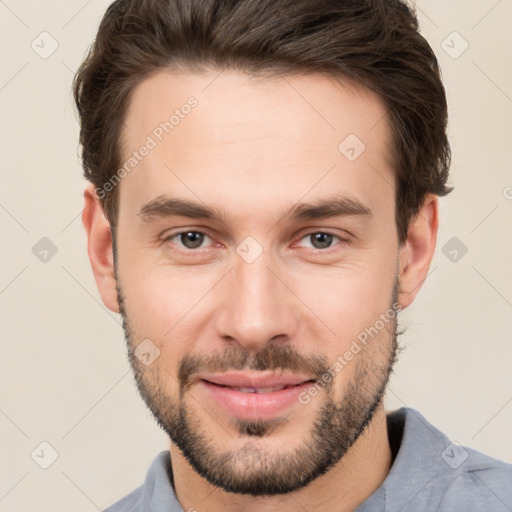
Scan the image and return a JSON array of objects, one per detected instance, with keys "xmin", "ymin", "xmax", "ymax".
[{"xmin": 197, "ymin": 372, "xmax": 314, "ymax": 420}]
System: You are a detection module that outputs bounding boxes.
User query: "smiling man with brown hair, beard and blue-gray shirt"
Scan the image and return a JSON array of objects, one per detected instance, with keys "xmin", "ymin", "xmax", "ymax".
[{"xmin": 75, "ymin": 0, "xmax": 512, "ymax": 512}]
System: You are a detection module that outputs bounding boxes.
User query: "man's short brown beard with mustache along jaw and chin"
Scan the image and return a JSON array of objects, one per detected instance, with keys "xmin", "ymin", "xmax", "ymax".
[{"xmin": 117, "ymin": 279, "xmax": 398, "ymax": 496}]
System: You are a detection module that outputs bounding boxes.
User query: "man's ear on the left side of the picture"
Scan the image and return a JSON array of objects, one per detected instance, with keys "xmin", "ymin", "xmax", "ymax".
[{"xmin": 82, "ymin": 183, "xmax": 119, "ymax": 313}]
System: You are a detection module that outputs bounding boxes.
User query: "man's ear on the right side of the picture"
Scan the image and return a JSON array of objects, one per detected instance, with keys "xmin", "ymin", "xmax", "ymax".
[{"xmin": 398, "ymin": 194, "xmax": 439, "ymax": 309}]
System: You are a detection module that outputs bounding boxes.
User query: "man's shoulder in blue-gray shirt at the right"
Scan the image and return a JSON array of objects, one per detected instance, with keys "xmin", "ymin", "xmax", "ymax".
[{"xmin": 380, "ymin": 407, "xmax": 512, "ymax": 512}]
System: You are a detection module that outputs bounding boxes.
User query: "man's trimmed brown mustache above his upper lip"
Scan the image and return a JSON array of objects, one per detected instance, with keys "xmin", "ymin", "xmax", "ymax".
[{"xmin": 178, "ymin": 345, "xmax": 329, "ymax": 390}]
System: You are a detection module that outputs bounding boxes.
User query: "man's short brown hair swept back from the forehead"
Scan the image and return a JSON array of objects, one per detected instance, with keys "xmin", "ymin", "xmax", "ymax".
[{"xmin": 73, "ymin": 0, "xmax": 451, "ymax": 243}]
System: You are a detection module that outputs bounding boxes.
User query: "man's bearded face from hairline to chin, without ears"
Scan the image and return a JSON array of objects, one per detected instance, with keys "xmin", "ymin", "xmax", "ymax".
[{"xmin": 115, "ymin": 71, "xmax": 400, "ymax": 495}]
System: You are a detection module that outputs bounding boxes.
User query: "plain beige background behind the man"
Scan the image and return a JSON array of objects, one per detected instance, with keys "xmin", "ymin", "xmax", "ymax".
[{"xmin": 0, "ymin": 0, "xmax": 512, "ymax": 512}]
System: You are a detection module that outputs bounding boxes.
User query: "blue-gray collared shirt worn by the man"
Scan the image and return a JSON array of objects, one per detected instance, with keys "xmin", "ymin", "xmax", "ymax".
[{"xmin": 104, "ymin": 407, "xmax": 512, "ymax": 512}]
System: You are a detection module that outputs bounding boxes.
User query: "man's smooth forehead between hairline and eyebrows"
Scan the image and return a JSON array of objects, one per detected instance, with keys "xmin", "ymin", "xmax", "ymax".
[{"xmin": 120, "ymin": 70, "xmax": 394, "ymax": 218}]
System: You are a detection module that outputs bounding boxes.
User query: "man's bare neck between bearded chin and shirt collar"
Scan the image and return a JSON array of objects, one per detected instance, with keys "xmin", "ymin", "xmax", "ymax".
[{"xmin": 170, "ymin": 404, "xmax": 392, "ymax": 512}]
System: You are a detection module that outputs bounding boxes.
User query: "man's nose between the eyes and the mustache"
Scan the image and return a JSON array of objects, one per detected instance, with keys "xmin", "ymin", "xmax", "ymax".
[{"xmin": 215, "ymin": 252, "xmax": 298, "ymax": 352}]
